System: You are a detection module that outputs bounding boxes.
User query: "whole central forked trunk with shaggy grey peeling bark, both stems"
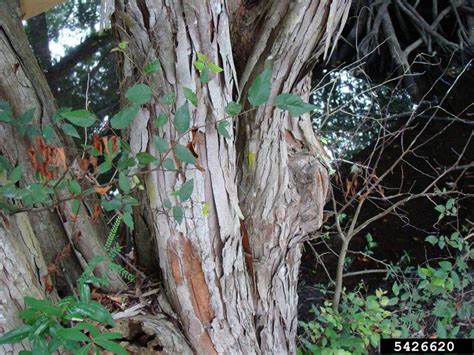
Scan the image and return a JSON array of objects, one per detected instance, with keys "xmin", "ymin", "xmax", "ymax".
[{"xmin": 114, "ymin": 0, "xmax": 350, "ymax": 354}]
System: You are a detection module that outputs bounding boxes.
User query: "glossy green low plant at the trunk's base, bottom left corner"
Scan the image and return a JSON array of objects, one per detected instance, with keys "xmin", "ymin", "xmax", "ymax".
[{"xmin": 0, "ymin": 257, "xmax": 127, "ymax": 355}]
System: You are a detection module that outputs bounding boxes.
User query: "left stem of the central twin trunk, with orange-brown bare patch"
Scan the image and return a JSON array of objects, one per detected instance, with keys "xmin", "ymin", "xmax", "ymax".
[{"xmin": 116, "ymin": 0, "xmax": 258, "ymax": 354}]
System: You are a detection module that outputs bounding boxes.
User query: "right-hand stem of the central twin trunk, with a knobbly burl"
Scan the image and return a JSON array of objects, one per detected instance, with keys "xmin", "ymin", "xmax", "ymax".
[{"xmin": 239, "ymin": 1, "xmax": 347, "ymax": 353}]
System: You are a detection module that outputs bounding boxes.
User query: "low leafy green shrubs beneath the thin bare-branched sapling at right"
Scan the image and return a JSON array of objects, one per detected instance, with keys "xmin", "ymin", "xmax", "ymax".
[{"xmin": 299, "ymin": 199, "xmax": 474, "ymax": 354}]
